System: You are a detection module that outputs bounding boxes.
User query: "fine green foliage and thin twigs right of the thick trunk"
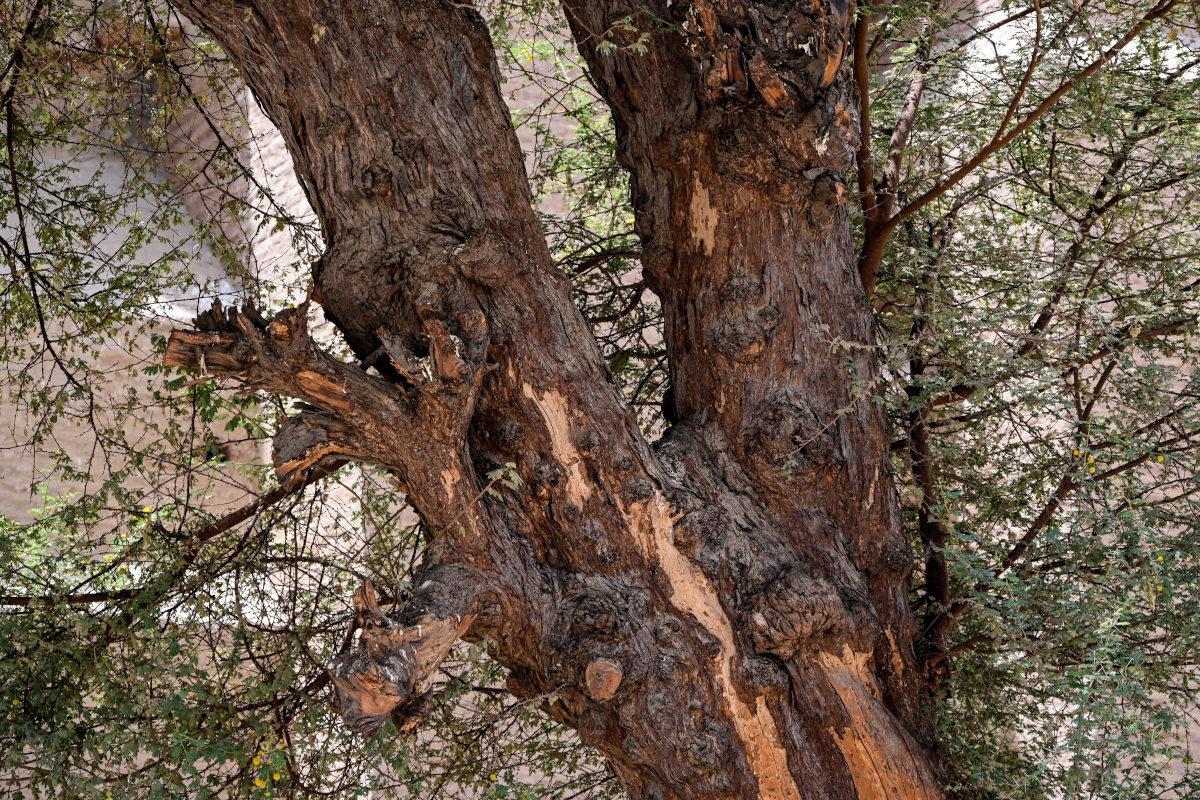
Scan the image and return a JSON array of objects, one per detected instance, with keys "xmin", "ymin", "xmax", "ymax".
[{"xmin": 872, "ymin": 2, "xmax": 1200, "ymax": 800}]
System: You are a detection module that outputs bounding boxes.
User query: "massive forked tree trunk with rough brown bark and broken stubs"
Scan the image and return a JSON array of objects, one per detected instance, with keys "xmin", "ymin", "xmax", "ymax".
[{"xmin": 167, "ymin": 0, "xmax": 942, "ymax": 800}]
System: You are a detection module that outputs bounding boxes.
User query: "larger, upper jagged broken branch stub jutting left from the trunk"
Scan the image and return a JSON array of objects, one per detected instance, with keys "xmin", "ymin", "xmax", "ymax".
[{"xmin": 162, "ymin": 301, "xmax": 484, "ymax": 494}]
